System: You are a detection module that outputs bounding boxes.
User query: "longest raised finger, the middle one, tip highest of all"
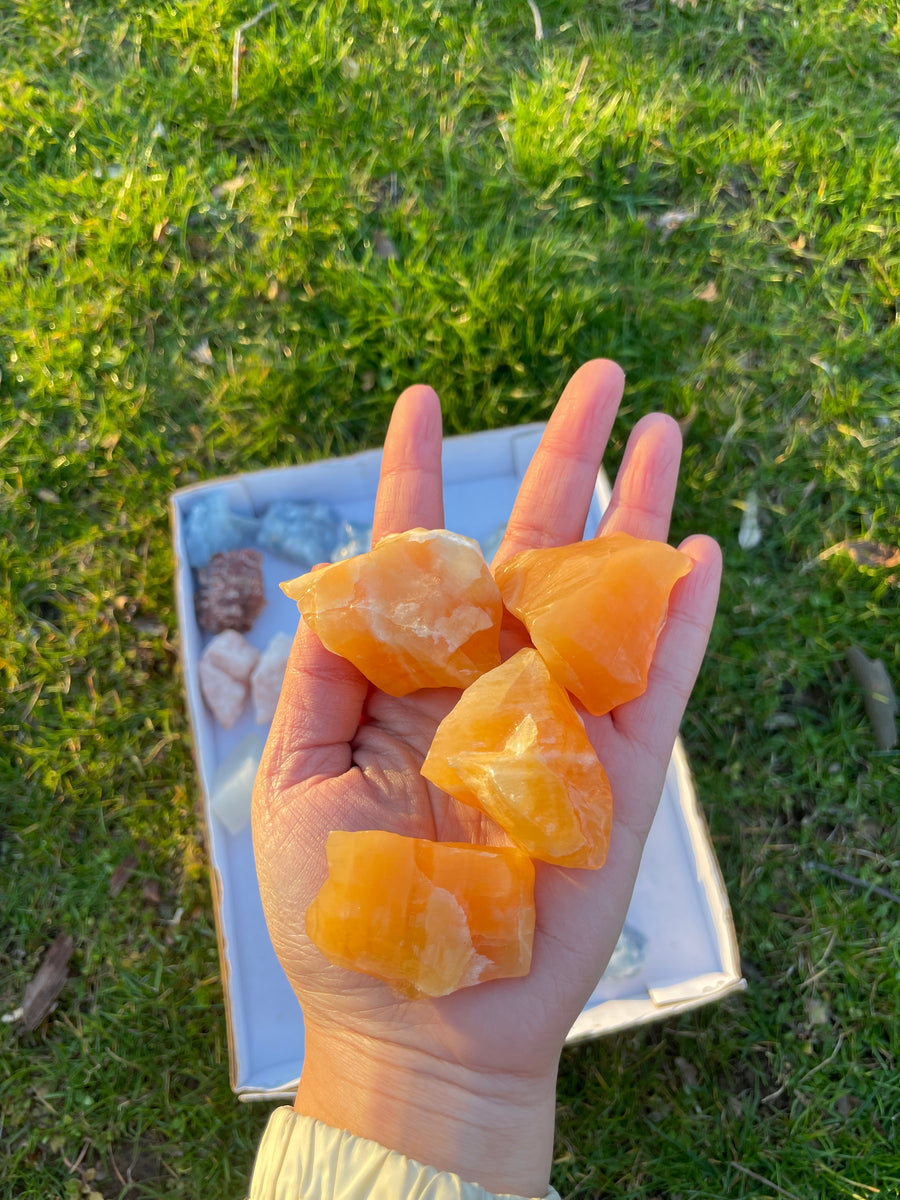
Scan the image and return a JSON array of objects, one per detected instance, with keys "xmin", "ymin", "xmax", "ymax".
[{"xmin": 494, "ymin": 359, "xmax": 625, "ymax": 563}]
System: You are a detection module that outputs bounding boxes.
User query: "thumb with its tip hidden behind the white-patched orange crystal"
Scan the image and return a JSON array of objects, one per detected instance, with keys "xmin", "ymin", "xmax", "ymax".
[{"xmin": 260, "ymin": 620, "xmax": 368, "ymax": 797}]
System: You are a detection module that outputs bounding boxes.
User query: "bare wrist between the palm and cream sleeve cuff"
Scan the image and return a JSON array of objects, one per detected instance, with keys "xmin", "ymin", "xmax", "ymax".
[{"xmin": 294, "ymin": 1026, "xmax": 556, "ymax": 1196}]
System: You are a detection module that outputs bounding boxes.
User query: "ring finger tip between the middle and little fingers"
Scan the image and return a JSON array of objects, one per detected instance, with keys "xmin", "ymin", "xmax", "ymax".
[{"xmin": 599, "ymin": 413, "xmax": 682, "ymax": 541}]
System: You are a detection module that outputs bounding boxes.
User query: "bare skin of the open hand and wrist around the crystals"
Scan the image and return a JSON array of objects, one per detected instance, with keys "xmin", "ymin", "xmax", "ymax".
[{"xmin": 253, "ymin": 360, "xmax": 721, "ymax": 1196}]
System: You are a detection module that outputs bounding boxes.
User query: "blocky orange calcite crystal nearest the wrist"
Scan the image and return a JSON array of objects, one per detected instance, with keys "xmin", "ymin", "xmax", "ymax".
[{"xmin": 306, "ymin": 830, "xmax": 534, "ymax": 998}]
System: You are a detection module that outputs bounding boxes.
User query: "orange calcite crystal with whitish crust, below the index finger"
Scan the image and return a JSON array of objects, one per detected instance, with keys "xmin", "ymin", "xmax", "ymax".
[{"xmin": 281, "ymin": 529, "xmax": 503, "ymax": 696}]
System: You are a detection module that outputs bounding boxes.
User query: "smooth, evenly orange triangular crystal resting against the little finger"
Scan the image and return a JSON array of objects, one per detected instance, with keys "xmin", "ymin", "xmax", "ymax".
[{"xmin": 494, "ymin": 533, "xmax": 694, "ymax": 716}]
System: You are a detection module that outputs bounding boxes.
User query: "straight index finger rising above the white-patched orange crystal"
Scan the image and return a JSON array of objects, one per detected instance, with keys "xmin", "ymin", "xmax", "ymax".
[{"xmin": 372, "ymin": 384, "xmax": 444, "ymax": 542}]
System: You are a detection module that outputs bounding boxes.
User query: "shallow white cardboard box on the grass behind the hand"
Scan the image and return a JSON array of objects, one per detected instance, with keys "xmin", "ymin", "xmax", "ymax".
[{"xmin": 172, "ymin": 425, "xmax": 744, "ymax": 1099}]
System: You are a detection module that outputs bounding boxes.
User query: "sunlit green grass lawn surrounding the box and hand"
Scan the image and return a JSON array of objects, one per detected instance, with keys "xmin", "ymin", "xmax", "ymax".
[{"xmin": 0, "ymin": 0, "xmax": 900, "ymax": 1200}]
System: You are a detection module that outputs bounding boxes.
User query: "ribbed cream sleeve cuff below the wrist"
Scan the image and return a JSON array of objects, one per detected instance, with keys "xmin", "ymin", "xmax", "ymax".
[{"xmin": 243, "ymin": 1108, "xmax": 559, "ymax": 1200}]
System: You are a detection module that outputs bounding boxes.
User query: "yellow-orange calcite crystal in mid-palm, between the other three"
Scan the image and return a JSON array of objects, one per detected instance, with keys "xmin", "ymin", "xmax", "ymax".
[{"xmin": 422, "ymin": 649, "xmax": 612, "ymax": 868}]
